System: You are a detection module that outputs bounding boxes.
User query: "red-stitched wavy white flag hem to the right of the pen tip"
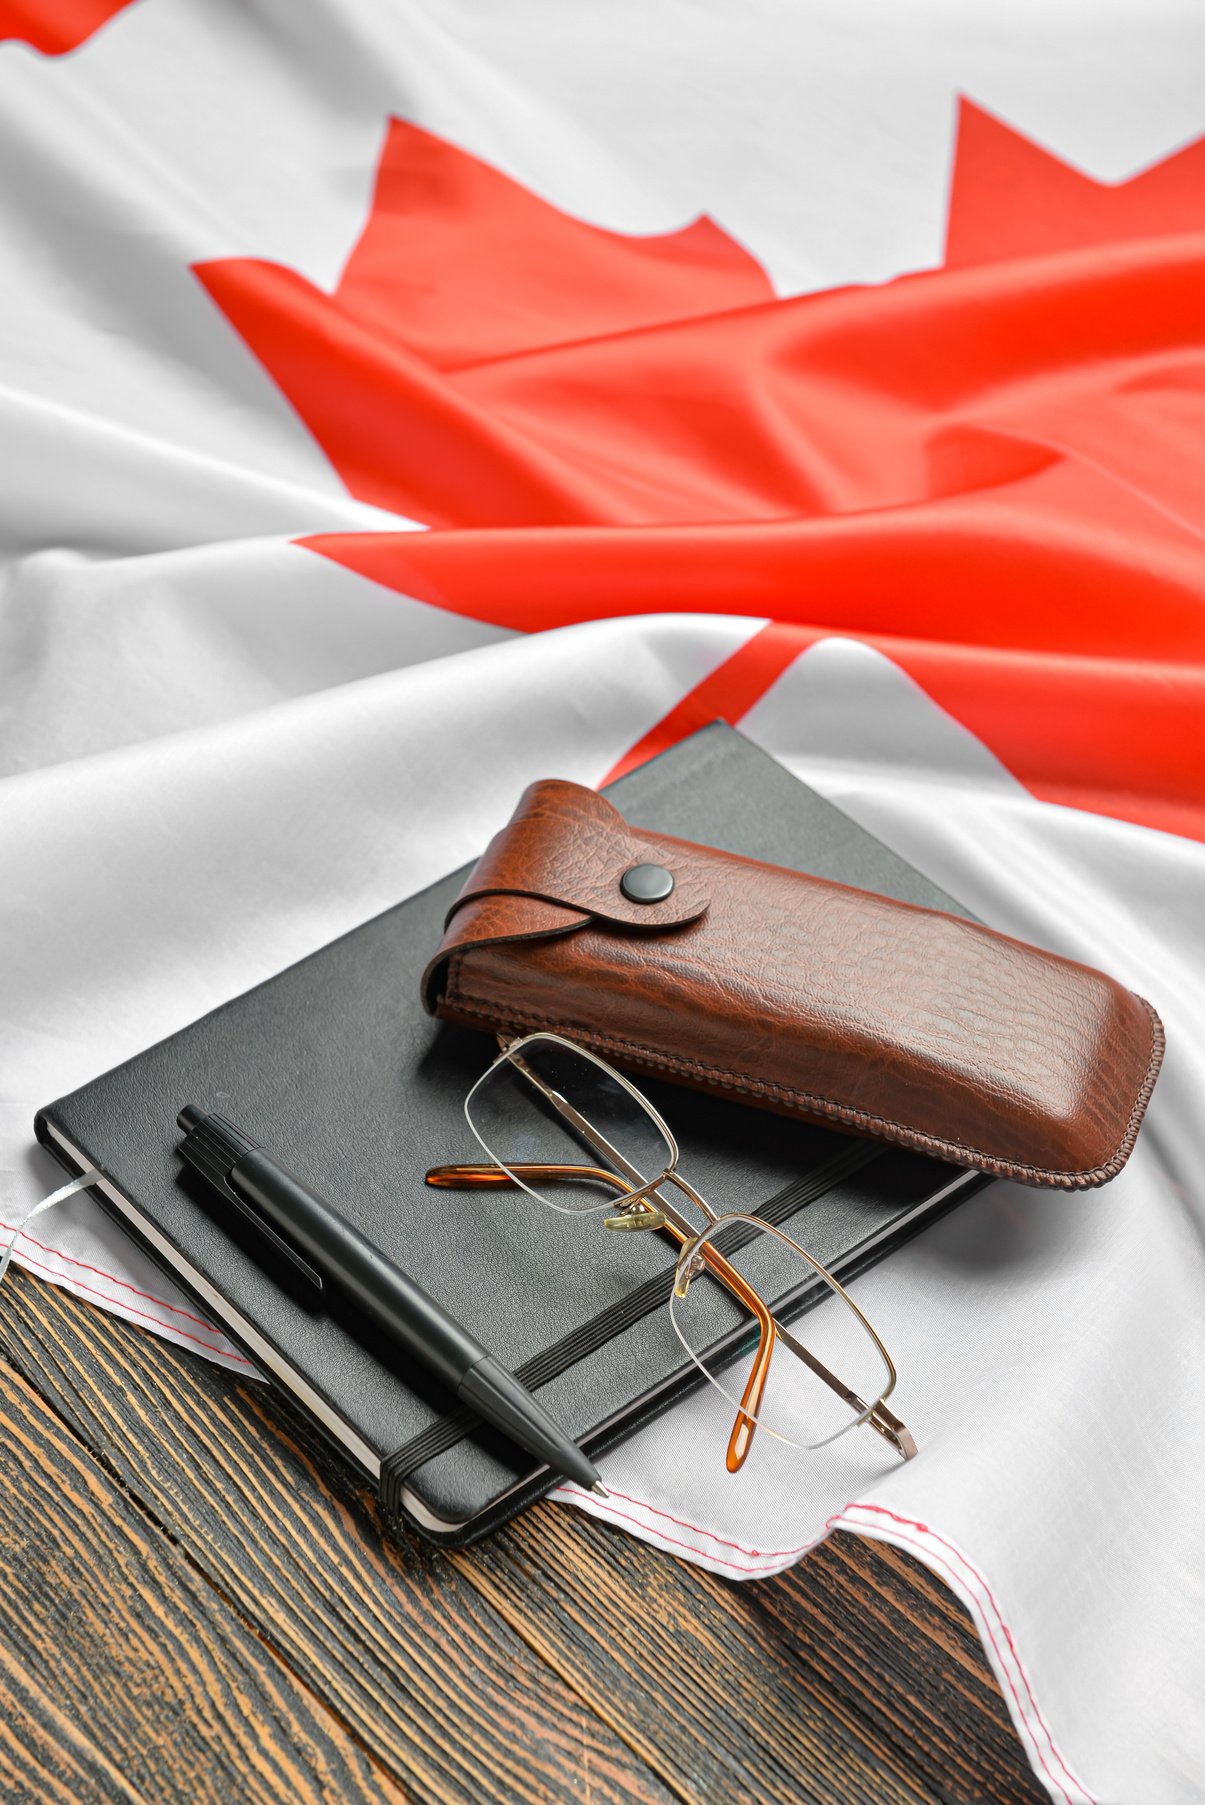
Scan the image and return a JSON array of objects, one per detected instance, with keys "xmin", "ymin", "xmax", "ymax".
[{"xmin": 550, "ymin": 1486, "xmax": 1097, "ymax": 1805}]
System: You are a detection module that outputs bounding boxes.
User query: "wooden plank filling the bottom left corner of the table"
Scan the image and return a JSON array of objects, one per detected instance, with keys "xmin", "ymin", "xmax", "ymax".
[{"xmin": 0, "ymin": 1363, "xmax": 404, "ymax": 1805}]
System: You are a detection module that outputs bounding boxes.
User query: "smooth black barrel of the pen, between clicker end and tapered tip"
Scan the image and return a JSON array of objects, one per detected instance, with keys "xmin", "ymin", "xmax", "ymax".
[{"xmin": 225, "ymin": 1148, "xmax": 485, "ymax": 1392}]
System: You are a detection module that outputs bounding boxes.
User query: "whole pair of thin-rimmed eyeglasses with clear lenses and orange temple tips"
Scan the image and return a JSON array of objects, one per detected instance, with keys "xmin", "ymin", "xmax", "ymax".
[{"xmin": 428, "ymin": 1034, "xmax": 916, "ymax": 1473}]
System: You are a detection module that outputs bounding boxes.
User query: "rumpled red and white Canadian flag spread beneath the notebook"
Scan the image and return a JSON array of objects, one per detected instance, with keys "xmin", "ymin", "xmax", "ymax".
[{"xmin": 0, "ymin": 14, "xmax": 1205, "ymax": 1805}]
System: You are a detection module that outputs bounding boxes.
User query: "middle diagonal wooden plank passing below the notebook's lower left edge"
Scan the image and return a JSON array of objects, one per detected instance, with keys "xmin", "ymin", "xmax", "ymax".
[{"xmin": 0, "ymin": 1274, "xmax": 669, "ymax": 1805}]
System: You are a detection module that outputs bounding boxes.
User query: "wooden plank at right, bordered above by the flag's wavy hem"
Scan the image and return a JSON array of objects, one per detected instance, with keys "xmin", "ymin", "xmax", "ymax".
[{"xmin": 453, "ymin": 1505, "xmax": 1044, "ymax": 1805}]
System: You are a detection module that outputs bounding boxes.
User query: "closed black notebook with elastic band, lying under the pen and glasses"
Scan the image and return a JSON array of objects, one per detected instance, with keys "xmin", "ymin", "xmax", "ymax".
[{"xmin": 36, "ymin": 722, "xmax": 985, "ymax": 1543}]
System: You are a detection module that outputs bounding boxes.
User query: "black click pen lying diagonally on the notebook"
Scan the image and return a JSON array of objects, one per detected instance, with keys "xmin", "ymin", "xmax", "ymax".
[{"xmin": 177, "ymin": 1103, "xmax": 606, "ymax": 1498}]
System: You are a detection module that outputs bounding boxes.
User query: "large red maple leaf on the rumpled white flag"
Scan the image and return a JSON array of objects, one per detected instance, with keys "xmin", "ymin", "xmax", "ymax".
[{"xmin": 198, "ymin": 105, "xmax": 1205, "ymax": 836}]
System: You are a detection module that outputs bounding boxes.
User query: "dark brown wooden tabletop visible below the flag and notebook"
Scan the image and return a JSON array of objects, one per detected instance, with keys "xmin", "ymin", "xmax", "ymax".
[{"xmin": 0, "ymin": 1271, "xmax": 1044, "ymax": 1805}]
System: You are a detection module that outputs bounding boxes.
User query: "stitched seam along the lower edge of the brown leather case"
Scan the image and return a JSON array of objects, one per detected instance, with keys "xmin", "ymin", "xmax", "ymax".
[{"xmin": 447, "ymin": 973, "xmax": 1165, "ymax": 1191}]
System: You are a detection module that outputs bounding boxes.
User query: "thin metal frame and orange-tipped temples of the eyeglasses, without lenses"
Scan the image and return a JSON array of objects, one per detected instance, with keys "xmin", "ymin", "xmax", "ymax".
[{"xmin": 426, "ymin": 1031, "xmax": 916, "ymax": 1473}]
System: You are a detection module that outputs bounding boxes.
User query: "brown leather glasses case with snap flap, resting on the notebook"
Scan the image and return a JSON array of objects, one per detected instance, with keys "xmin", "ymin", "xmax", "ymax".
[{"xmin": 424, "ymin": 782, "xmax": 1164, "ymax": 1189}]
